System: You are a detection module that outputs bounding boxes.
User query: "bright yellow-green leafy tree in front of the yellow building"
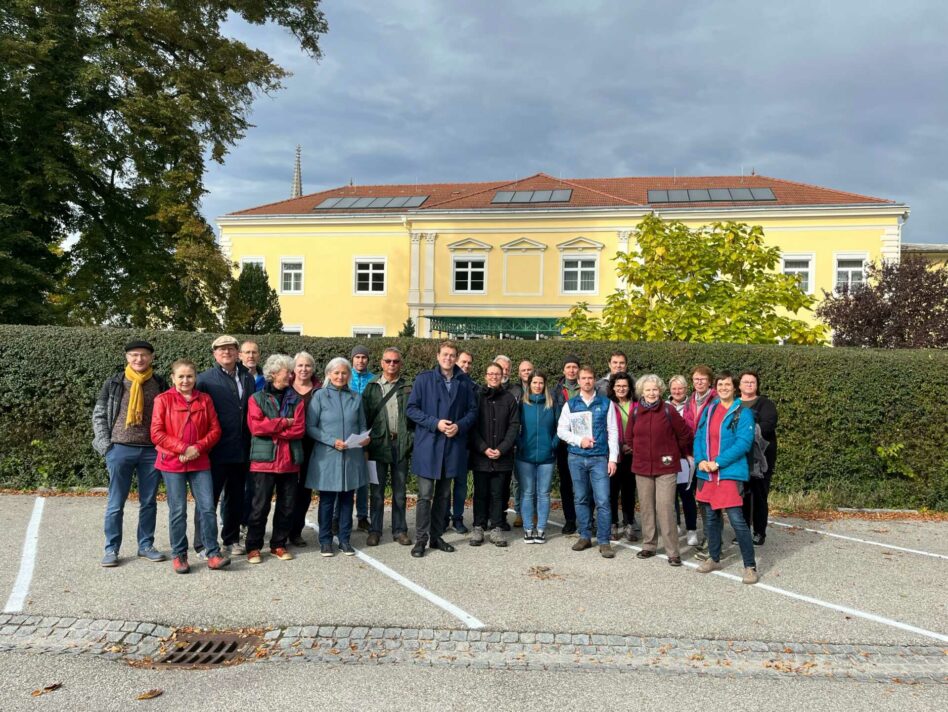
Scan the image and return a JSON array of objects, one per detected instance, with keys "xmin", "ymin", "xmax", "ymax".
[{"xmin": 560, "ymin": 215, "xmax": 824, "ymax": 344}]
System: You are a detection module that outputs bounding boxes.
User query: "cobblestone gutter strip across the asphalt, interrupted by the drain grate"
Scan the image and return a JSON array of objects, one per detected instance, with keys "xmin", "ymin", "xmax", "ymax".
[{"xmin": 0, "ymin": 614, "xmax": 948, "ymax": 685}]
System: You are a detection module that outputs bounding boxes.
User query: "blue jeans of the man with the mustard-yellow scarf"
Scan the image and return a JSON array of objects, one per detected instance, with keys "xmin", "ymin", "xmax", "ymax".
[{"xmin": 105, "ymin": 443, "xmax": 161, "ymax": 554}]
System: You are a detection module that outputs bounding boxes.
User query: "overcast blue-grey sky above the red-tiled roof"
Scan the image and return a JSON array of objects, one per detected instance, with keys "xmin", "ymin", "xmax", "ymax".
[{"xmin": 204, "ymin": 0, "xmax": 948, "ymax": 242}]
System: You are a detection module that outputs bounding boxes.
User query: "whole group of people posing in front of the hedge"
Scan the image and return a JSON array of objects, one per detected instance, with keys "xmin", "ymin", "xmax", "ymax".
[{"xmin": 93, "ymin": 336, "xmax": 777, "ymax": 583}]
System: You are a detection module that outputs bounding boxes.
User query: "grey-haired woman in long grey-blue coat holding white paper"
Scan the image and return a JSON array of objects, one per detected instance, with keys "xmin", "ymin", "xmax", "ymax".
[{"xmin": 306, "ymin": 357, "xmax": 370, "ymax": 556}]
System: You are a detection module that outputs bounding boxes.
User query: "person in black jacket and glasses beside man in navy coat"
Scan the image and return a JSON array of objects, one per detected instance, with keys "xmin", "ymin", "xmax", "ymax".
[{"xmin": 469, "ymin": 362, "xmax": 520, "ymax": 546}]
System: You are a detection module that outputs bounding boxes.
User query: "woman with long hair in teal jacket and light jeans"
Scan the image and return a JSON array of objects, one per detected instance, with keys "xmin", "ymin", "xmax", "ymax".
[{"xmin": 515, "ymin": 371, "xmax": 560, "ymax": 544}]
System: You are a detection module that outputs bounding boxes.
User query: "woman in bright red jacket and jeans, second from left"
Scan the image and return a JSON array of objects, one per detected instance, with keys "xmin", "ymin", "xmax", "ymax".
[{"xmin": 151, "ymin": 359, "xmax": 230, "ymax": 574}]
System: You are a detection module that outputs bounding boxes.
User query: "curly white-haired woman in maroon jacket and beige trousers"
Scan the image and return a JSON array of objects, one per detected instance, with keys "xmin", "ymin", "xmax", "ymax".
[{"xmin": 625, "ymin": 373, "xmax": 694, "ymax": 566}]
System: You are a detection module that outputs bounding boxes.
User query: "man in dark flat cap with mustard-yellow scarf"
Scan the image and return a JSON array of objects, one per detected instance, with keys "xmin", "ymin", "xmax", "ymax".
[{"xmin": 92, "ymin": 340, "xmax": 168, "ymax": 567}]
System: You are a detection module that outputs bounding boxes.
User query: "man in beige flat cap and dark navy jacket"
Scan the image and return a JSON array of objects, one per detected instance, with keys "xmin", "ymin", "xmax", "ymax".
[{"xmin": 194, "ymin": 336, "xmax": 254, "ymax": 556}]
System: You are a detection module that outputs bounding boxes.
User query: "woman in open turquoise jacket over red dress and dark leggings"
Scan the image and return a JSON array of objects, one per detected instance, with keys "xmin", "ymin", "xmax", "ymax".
[{"xmin": 694, "ymin": 371, "xmax": 759, "ymax": 583}]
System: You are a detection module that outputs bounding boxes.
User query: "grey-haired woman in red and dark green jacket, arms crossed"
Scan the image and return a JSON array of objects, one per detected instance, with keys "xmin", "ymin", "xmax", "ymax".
[{"xmin": 247, "ymin": 354, "xmax": 306, "ymax": 564}]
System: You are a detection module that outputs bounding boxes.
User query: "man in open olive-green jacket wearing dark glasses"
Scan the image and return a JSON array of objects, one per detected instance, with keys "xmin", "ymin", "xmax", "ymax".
[{"xmin": 362, "ymin": 346, "xmax": 414, "ymax": 546}]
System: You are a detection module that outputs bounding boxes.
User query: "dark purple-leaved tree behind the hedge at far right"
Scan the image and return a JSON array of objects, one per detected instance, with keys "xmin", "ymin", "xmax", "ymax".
[{"xmin": 816, "ymin": 256, "xmax": 948, "ymax": 349}]
